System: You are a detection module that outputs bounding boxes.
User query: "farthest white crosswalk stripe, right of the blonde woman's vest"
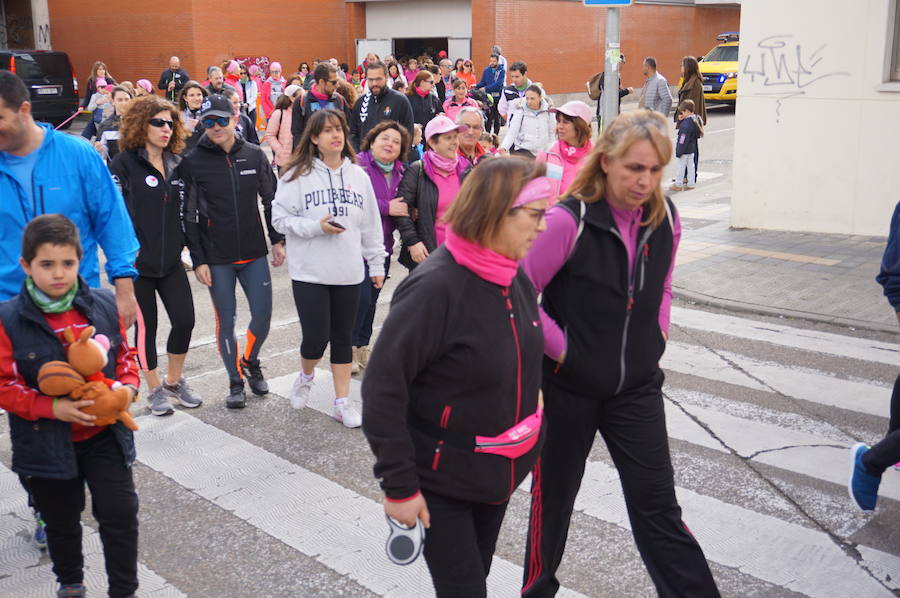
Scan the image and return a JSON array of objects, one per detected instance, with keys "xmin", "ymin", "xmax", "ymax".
[{"xmin": 672, "ymin": 306, "xmax": 900, "ymax": 365}]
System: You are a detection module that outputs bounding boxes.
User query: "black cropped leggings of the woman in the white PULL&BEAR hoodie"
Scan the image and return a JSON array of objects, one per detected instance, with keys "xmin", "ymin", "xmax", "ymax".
[{"xmin": 291, "ymin": 280, "xmax": 356, "ymax": 364}]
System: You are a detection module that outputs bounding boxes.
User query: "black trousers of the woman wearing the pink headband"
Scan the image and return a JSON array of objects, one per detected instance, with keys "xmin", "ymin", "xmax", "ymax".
[{"xmin": 422, "ymin": 490, "xmax": 508, "ymax": 598}]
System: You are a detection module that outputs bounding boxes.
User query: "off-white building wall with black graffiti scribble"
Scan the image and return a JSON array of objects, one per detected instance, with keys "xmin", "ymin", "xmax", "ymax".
[{"xmin": 731, "ymin": 0, "xmax": 900, "ymax": 235}]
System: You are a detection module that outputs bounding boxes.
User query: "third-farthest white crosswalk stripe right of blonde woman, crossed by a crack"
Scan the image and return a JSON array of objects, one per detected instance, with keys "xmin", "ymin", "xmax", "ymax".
[{"xmin": 666, "ymin": 389, "xmax": 900, "ymax": 500}]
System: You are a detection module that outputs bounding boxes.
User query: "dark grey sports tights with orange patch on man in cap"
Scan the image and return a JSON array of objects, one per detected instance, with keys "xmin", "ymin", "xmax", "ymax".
[{"xmin": 209, "ymin": 256, "xmax": 272, "ymax": 384}]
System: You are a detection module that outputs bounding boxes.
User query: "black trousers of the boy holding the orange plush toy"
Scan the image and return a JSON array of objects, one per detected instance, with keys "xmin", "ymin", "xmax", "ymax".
[{"xmin": 22, "ymin": 429, "xmax": 138, "ymax": 598}]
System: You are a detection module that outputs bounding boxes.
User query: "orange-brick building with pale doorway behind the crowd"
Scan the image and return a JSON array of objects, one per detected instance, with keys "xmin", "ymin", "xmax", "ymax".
[{"xmin": 37, "ymin": 0, "xmax": 740, "ymax": 93}]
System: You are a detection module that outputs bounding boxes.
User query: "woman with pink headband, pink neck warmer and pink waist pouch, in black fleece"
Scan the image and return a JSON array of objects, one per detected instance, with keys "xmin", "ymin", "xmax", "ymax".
[{"xmin": 362, "ymin": 157, "xmax": 553, "ymax": 598}]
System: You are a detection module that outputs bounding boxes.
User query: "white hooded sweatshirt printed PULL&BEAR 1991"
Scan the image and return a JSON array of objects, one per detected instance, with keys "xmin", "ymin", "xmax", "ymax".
[{"xmin": 272, "ymin": 158, "xmax": 386, "ymax": 285}]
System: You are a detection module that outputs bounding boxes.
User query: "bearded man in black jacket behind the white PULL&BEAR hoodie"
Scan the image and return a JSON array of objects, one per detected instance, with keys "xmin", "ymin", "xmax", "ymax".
[{"xmin": 350, "ymin": 61, "xmax": 413, "ymax": 151}]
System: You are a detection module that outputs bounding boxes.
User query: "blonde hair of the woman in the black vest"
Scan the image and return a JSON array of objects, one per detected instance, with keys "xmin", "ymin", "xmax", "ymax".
[{"xmin": 569, "ymin": 110, "xmax": 672, "ymax": 227}]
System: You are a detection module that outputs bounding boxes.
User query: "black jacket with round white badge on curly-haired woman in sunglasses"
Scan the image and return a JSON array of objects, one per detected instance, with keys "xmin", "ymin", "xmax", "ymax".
[{"xmin": 109, "ymin": 148, "xmax": 185, "ymax": 278}]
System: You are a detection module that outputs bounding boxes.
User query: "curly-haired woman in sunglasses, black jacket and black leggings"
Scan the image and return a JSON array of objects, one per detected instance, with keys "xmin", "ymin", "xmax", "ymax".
[{"xmin": 109, "ymin": 95, "xmax": 203, "ymax": 416}]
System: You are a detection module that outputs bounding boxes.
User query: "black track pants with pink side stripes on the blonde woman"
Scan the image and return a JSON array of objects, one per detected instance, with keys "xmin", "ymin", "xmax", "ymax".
[{"xmin": 522, "ymin": 367, "xmax": 719, "ymax": 598}]
